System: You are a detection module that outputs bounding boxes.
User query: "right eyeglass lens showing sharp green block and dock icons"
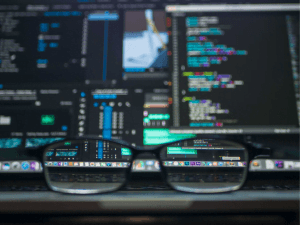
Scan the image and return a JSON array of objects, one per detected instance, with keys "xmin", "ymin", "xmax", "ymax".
[{"xmin": 161, "ymin": 139, "xmax": 248, "ymax": 193}]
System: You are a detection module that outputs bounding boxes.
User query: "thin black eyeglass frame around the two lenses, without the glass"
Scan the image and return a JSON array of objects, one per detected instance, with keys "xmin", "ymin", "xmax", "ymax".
[{"xmin": 25, "ymin": 136, "xmax": 254, "ymax": 195}]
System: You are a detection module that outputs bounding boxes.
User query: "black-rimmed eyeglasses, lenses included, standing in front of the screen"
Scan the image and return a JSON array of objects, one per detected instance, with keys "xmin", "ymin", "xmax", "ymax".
[{"xmin": 28, "ymin": 139, "xmax": 248, "ymax": 194}]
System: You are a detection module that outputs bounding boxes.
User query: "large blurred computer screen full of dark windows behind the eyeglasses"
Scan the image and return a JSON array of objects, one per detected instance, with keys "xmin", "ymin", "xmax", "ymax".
[{"xmin": 0, "ymin": 0, "xmax": 300, "ymax": 174}]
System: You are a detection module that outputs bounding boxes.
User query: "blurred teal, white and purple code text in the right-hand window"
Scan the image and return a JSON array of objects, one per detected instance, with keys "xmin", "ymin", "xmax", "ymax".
[{"xmin": 182, "ymin": 16, "xmax": 248, "ymax": 127}]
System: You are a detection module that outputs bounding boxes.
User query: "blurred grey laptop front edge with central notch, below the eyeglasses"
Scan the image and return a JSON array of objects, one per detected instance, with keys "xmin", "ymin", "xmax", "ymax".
[{"xmin": 0, "ymin": 191, "xmax": 300, "ymax": 214}]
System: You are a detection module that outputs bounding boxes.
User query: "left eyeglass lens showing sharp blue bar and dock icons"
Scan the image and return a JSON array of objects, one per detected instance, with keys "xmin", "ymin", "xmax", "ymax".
[{"xmin": 44, "ymin": 140, "xmax": 131, "ymax": 194}]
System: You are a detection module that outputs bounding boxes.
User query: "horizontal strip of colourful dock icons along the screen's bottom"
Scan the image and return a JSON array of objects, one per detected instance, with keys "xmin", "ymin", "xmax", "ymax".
[{"xmin": 0, "ymin": 159, "xmax": 300, "ymax": 173}]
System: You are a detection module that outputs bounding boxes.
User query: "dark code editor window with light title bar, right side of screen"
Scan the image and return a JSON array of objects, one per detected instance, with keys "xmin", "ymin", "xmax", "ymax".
[{"xmin": 166, "ymin": 4, "xmax": 300, "ymax": 134}]
